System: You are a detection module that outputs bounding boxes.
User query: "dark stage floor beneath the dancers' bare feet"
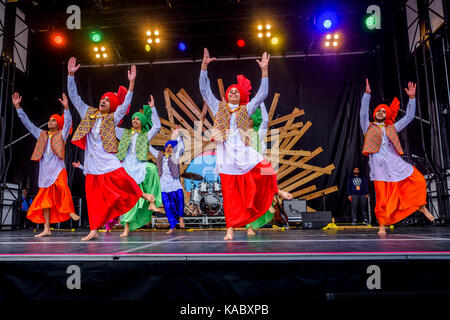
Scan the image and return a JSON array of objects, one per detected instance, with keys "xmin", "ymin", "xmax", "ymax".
[{"xmin": 0, "ymin": 226, "xmax": 450, "ymax": 261}]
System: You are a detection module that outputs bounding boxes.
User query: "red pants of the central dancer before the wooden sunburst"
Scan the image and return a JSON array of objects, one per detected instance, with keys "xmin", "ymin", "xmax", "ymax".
[{"xmin": 220, "ymin": 160, "xmax": 278, "ymax": 228}]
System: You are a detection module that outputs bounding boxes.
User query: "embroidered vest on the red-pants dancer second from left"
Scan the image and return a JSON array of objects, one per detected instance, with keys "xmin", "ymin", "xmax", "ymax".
[{"xmin": 72, "ymin": 107, "xmax": 119, "ymax": 153}]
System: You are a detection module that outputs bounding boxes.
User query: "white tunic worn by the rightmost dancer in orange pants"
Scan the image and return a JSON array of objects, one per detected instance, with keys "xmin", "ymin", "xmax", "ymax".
[{"xmin": 360, "ymin": 93, "xmax": 416, "ymax": 182}]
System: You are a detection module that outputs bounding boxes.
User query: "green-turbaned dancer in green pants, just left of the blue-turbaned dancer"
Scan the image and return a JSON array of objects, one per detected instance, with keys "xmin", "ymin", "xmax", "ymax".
[{"xmin": 116, "ymin": 95, "xmax": 162, "ymax": 237}]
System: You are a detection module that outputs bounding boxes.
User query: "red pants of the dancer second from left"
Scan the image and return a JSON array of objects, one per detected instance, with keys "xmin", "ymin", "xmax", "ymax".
[{"xmin": 85, "ymin": 168, "xmax": 142, "ymax": 230}]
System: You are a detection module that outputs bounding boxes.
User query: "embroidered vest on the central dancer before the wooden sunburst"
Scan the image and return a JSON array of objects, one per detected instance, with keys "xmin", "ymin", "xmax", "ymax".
[{"xmin": 212, "ymin": 102, "xmax": 251, "ymax": 146}]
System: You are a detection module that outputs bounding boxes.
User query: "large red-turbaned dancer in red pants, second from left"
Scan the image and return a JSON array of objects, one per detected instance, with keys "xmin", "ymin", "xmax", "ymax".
[{"xmin": 67, "ymin": 57, "xmax": 152, "ymax": 241}]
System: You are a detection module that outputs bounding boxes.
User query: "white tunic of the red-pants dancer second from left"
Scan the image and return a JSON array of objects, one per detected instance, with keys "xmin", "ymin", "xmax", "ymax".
[{"xmin": 67, "ymin": 75, "xmax": 133, "ymax": 175}]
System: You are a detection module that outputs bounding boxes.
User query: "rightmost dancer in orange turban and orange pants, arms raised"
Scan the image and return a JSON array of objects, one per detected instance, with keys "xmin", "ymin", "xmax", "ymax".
[{"xmin": 360, "ymin": 79, "xmax": 434, "ymax": 236}]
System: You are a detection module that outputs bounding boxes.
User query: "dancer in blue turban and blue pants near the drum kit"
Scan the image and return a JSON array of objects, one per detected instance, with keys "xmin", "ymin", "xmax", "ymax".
[{"xmin": 149, "ymin": 129, "xmax": 185, "ymax": 234}]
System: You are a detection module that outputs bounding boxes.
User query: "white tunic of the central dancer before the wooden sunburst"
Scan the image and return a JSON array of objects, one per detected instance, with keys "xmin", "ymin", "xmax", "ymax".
[{"xmin": 199, "ymin": 70, "xmax": 269, "ymax": 175}]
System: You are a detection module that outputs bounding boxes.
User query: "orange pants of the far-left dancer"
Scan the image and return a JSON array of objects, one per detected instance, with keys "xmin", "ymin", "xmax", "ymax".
[{"xmin": 27, "ymin": 169, "xmax": 75, "ymax": 223}]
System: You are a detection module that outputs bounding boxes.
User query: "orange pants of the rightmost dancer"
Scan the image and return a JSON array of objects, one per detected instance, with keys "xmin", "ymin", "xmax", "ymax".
[{"xmin": 374, "ymin": 168, "xmax": 427, "ymax": 226}]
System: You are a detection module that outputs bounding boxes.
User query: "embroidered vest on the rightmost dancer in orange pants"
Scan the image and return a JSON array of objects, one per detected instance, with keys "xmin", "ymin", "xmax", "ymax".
[{"xmin": 362, "ymin": 123, "xmax": 404, "ymax": 156}]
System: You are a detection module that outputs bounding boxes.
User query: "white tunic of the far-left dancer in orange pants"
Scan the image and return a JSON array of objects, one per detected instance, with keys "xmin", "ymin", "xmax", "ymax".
[{"xmin": 16, "ymin": 109, "xmax": 72, "ymax": 188}]
